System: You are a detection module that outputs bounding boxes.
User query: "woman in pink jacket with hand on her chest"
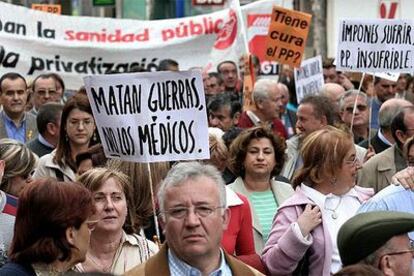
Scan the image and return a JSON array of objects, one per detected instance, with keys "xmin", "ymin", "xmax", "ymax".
[{"xmin": 262, "ymin": 126, "xmax": 373, "ymax": 275}]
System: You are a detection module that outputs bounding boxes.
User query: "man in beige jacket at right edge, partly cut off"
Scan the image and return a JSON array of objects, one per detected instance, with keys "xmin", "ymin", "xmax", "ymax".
[{"xmin": 358, "ymin": 106, "xmax": 414, "ymax": 192}]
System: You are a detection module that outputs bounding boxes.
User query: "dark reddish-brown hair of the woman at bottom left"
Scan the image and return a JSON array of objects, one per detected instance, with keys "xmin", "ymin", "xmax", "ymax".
[{"xmin": 9, "ymin": 178, "xmax": 95, "ymax": 264}]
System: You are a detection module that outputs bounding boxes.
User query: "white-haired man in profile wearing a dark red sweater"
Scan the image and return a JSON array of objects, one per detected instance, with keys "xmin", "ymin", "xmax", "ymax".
[{"xmin": 238, "ymin": 79, "xmax": 287, "ymax": 138}]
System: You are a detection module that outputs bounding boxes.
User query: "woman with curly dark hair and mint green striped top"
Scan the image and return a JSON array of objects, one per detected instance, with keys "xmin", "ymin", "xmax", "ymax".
[{"xmin": 229, "ymin": 126, "xmax": 293, "ymax": 254}]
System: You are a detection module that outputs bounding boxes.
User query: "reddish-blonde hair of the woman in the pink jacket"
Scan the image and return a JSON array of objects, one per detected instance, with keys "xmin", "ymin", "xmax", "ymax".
[{"xmin": 292, "ymin": 126, "xmax": 354, "ymax": 188}]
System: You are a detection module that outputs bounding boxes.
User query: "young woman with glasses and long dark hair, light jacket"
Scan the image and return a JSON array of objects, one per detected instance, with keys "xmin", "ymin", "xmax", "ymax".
[{"xmin": 33, "ymin": 93, "xmax": 95, "ymax": 181}]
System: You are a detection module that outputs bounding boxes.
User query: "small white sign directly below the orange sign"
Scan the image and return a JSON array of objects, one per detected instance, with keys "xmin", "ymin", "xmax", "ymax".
[{"xmin": 294, "ymin": 56, "xmax": 324, "ymax": 102}]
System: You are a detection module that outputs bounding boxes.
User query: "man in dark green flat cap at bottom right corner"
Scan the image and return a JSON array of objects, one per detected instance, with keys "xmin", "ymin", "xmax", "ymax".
[{"xmin": 337, "ymin": 211, "xmax": 414, "ymax": 276}]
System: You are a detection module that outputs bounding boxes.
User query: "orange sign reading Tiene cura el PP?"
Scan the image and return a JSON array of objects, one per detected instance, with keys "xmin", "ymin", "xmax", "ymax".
[{"xmin": 265, "ymin": 6, "xmax": 312, "ymax": 67}]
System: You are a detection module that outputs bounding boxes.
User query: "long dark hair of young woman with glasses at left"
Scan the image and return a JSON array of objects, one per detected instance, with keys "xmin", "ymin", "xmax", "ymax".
[{"xmin": 53, "ymin": 93, "xmax": 93, "ymax": 171}]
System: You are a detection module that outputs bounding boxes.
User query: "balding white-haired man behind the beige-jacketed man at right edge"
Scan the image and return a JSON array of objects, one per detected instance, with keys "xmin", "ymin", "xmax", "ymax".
[{"xmin": 359, "ymin": 98, "xmax": 413, "ymax": 153}]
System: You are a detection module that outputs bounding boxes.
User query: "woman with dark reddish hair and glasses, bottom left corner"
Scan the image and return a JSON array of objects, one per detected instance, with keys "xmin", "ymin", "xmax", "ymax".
[{"xmin": 0, "ymin": 178, "xmax": 95, "ymax": 275}]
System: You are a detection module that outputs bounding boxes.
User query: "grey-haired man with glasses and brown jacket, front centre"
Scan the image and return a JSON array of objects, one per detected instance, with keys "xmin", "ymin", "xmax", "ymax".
[{"xmin": 126, "ymin": 162, "xmax": 261, "ymax": 276}]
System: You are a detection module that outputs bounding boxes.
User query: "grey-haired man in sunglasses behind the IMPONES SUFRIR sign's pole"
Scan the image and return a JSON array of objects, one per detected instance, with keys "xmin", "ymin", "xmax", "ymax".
[{"xmin": 339, "ymin": 90, "xmax": 376, "ymax": 144}]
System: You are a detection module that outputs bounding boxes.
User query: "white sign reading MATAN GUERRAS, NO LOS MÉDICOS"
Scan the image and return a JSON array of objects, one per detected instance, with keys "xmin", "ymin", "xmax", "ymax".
[{"xmin": 84, "ymin": 71, "xmax": 209, "ymax": 162}]
